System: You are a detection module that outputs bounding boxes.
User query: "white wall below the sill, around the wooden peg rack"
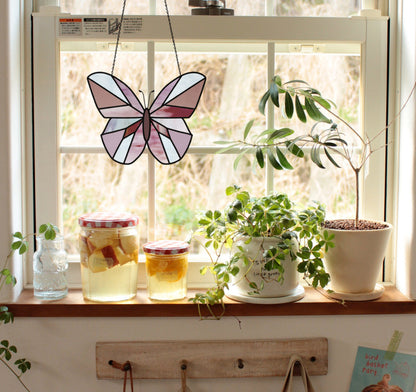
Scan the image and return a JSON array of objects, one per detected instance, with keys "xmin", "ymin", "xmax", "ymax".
[{"xmin": 0, "ymin": 315, "xmax": 416, "ymax": 392}]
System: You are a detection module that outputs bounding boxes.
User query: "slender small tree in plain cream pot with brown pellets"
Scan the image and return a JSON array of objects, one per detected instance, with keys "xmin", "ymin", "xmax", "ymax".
[{"xmin": 226, "ymin": 76, "xmax": 415, "ymax": 300}]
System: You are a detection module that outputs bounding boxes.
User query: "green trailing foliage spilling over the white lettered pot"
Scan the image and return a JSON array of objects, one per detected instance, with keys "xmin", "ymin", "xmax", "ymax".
[{"xmin": 190, "ymin": 185, "xmax": 334, "ymax": 319}]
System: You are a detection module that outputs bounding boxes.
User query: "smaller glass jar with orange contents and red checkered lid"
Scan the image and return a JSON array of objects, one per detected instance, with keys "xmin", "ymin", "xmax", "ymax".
[{"xmin": 143, "ymin": 240, "xmax": 189, "ymax": 301}]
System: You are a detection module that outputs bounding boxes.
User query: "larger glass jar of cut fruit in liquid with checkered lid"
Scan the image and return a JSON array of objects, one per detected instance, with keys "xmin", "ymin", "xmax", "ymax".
[{"xmin": 78, "ymin": 212, "xmax": 139, "ymax": 302}]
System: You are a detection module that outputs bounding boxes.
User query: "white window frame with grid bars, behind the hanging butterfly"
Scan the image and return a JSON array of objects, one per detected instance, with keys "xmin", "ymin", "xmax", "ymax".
[{"xmin": 31, "ymin": 7, "xmax": 394, "ymax": 286}]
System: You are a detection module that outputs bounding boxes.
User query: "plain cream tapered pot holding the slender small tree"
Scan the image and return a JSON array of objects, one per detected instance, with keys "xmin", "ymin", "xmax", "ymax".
[{"xmin": 324, "ymin": 223, "xmax": 392, "ymax": 300}]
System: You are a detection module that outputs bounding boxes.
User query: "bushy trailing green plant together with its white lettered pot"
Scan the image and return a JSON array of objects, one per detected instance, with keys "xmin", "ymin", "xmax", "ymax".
[{"xmin": 191, "ymin": 185, "xmax": 333, "ymax": 316}]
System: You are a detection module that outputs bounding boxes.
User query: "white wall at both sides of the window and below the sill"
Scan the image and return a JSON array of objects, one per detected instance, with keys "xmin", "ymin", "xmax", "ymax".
[{"xmin": 0, "ymin": 0, "xmax": 416, "ymax": 392}]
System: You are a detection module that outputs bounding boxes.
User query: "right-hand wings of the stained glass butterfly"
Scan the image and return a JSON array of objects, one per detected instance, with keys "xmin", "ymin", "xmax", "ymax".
[{"xmin": 144, "ymin": 72, "xmax": 206, "ymax": 165}]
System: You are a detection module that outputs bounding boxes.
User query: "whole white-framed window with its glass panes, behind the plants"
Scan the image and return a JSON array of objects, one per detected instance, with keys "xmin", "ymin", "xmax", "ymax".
[{"xmin": 29, "ymin": 1, "xmax": 387, "ymax": 285}]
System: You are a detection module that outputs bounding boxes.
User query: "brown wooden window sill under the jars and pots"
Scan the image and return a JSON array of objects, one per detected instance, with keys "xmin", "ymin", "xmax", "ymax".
[{"xmin": 7, "ymin": 286, "xmax": 416, "ymax": 317}]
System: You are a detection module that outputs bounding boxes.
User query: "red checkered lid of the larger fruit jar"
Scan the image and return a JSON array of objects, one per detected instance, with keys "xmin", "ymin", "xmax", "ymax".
[{"xmin": 78, "ymin": 212, "xmax": 139, "ymax": 229}]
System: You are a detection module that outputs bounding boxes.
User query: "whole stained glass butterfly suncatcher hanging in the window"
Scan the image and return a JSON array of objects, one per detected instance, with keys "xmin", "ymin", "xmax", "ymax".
[{"xmin": 87, "ymin": 72, "xmax": 206, "ymax": 165}]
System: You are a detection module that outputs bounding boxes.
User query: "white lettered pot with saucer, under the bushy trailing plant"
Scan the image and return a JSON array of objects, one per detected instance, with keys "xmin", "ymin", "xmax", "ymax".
[{"xmin": 227, "ymin": 238, "xmax": 304, "ymax": 303}]
